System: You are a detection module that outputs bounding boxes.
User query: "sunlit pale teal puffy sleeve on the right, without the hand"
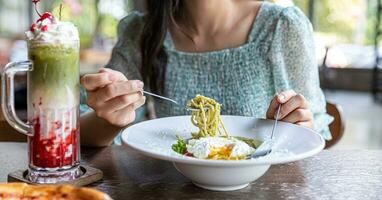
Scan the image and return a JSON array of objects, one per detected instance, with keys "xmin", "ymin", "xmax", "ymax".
[{"xmin": 270, "ymin": 7, "xmax": 333, "ymax": 140}]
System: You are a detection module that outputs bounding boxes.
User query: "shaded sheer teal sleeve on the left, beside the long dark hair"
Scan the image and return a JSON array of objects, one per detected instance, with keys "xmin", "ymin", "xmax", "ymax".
[{"xmin": 106, "ymin": 11, "xmax": 144, "ymax": 80}]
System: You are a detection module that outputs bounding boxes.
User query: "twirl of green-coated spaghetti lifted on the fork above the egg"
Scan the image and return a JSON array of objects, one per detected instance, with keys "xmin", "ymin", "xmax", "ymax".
[{"xmin": 187, "ymin": 95, "xmax": 228, "ymax": 138}]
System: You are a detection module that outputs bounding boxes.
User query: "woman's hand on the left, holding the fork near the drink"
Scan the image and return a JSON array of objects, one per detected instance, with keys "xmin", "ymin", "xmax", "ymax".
[{"xmin": 81, "ymin": 68, "xmax": 146, "ymax": 127}]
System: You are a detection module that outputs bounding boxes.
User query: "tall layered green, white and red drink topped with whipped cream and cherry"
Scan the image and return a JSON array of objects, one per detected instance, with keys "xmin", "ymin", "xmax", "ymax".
[{"xmin": 26, "ymin": 13, "xmax": 80, "ymax": 182}]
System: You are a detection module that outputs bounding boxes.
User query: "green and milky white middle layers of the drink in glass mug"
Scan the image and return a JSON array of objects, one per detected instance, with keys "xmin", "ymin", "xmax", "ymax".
[{"xmin": 28, "ymin": 41, "xmax": 80, "ymax": 109}]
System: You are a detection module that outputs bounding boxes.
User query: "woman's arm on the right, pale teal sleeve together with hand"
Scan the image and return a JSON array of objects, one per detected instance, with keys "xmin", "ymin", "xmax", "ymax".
[{"xmin": 267, "ymin": 7, "xmax": 331, "ymax": 139}]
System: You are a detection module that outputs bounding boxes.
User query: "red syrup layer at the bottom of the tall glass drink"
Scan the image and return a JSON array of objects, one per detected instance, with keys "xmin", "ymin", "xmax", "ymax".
[{"xmin": 29, "ymin": 117, "xmax": 79, "ymax": 168}]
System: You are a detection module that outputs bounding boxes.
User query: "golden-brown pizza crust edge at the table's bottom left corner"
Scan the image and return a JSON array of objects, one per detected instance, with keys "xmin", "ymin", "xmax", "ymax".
[{"xmin": 0, "ymin": 183, "xmax": 111, "ymax": 200}]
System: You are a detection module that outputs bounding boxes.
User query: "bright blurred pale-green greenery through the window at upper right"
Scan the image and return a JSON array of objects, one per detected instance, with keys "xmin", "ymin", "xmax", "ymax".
[{"xmin": 268, "ymin": 0, "xmax": 378, "ymax": 45}]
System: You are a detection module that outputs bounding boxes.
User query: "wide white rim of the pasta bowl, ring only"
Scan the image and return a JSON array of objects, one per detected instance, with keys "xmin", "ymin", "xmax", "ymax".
[{"xmin": 121, "ymin": 115, "xmax": 325, "ymax": 167}]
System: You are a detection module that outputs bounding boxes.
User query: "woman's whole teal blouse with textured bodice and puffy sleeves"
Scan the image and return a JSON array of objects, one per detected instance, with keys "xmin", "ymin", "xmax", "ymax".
[{"xmin": 82, "ymin": 3, "xmax": 332, "ymax": 139}]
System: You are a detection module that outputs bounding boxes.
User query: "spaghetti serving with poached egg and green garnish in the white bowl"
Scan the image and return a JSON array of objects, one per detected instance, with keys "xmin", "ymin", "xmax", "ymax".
[{"xmin": 172, "ymin": 95, "xmax": 257, "ymax": 160}]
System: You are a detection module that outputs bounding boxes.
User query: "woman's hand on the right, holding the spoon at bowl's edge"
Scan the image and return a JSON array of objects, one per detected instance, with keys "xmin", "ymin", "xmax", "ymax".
[{"xmin": 267, "ymin": 90, "xmax": 313, "ymax": 128}]
